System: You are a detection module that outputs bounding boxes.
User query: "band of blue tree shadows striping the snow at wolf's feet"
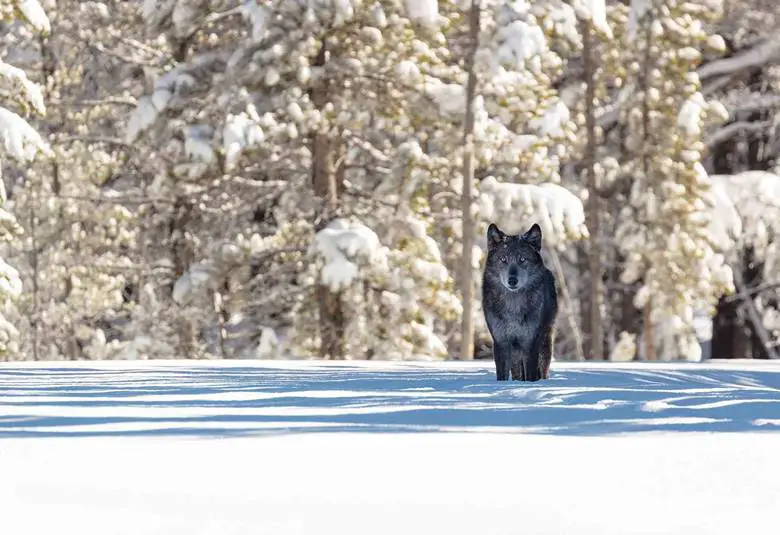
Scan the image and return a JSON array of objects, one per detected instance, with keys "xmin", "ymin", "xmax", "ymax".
[{"xmin": 0, "ymin": 363, "xmax": 780, "ymax": 438}]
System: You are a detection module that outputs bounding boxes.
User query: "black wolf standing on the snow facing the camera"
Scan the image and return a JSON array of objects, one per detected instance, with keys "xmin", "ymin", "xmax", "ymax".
[{"xmin": 482, "ymin": 223, "xmax": 558, "ymax": 381}]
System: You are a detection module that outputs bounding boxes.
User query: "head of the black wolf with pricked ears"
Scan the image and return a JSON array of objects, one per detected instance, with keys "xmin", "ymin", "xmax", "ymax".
[{"xmin": 485, "ymin": 223, "xmax": 544, "ymax": 292}]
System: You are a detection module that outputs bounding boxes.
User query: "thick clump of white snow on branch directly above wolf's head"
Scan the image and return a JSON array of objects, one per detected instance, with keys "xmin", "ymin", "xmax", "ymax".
[{"xmin": 480, "ymin": 177, "xmax": 589, "ymax": 246}]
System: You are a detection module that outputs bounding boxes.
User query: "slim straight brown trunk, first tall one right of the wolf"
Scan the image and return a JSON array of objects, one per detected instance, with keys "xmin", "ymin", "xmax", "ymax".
[{"xmin": 580, "ymin": 21, "xmax": 606, "ymax": 360}]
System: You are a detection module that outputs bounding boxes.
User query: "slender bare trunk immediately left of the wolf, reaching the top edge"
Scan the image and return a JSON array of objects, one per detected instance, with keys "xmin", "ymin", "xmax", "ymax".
[{"xmin": 460, "ymin": 0, "xmax": 481, "ymax": 360}]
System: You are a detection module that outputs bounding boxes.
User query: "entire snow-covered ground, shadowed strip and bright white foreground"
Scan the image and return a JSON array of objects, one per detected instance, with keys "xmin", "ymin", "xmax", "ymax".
[{"xmin": 0, "ymin": 361, "xmax": 780, "ymax": 535}]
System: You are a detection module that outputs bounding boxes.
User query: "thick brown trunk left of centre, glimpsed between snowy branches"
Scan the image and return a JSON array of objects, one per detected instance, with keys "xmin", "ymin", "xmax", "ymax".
[{"xmin": 312, "ymin": 38, "xmax": 346, "ymax": 360}]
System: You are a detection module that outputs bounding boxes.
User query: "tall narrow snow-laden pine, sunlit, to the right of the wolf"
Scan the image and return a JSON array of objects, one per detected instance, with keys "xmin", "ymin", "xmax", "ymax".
[{"xmin": 616, "ymin": 0, "xmax": 732, "ymax": 359}]
